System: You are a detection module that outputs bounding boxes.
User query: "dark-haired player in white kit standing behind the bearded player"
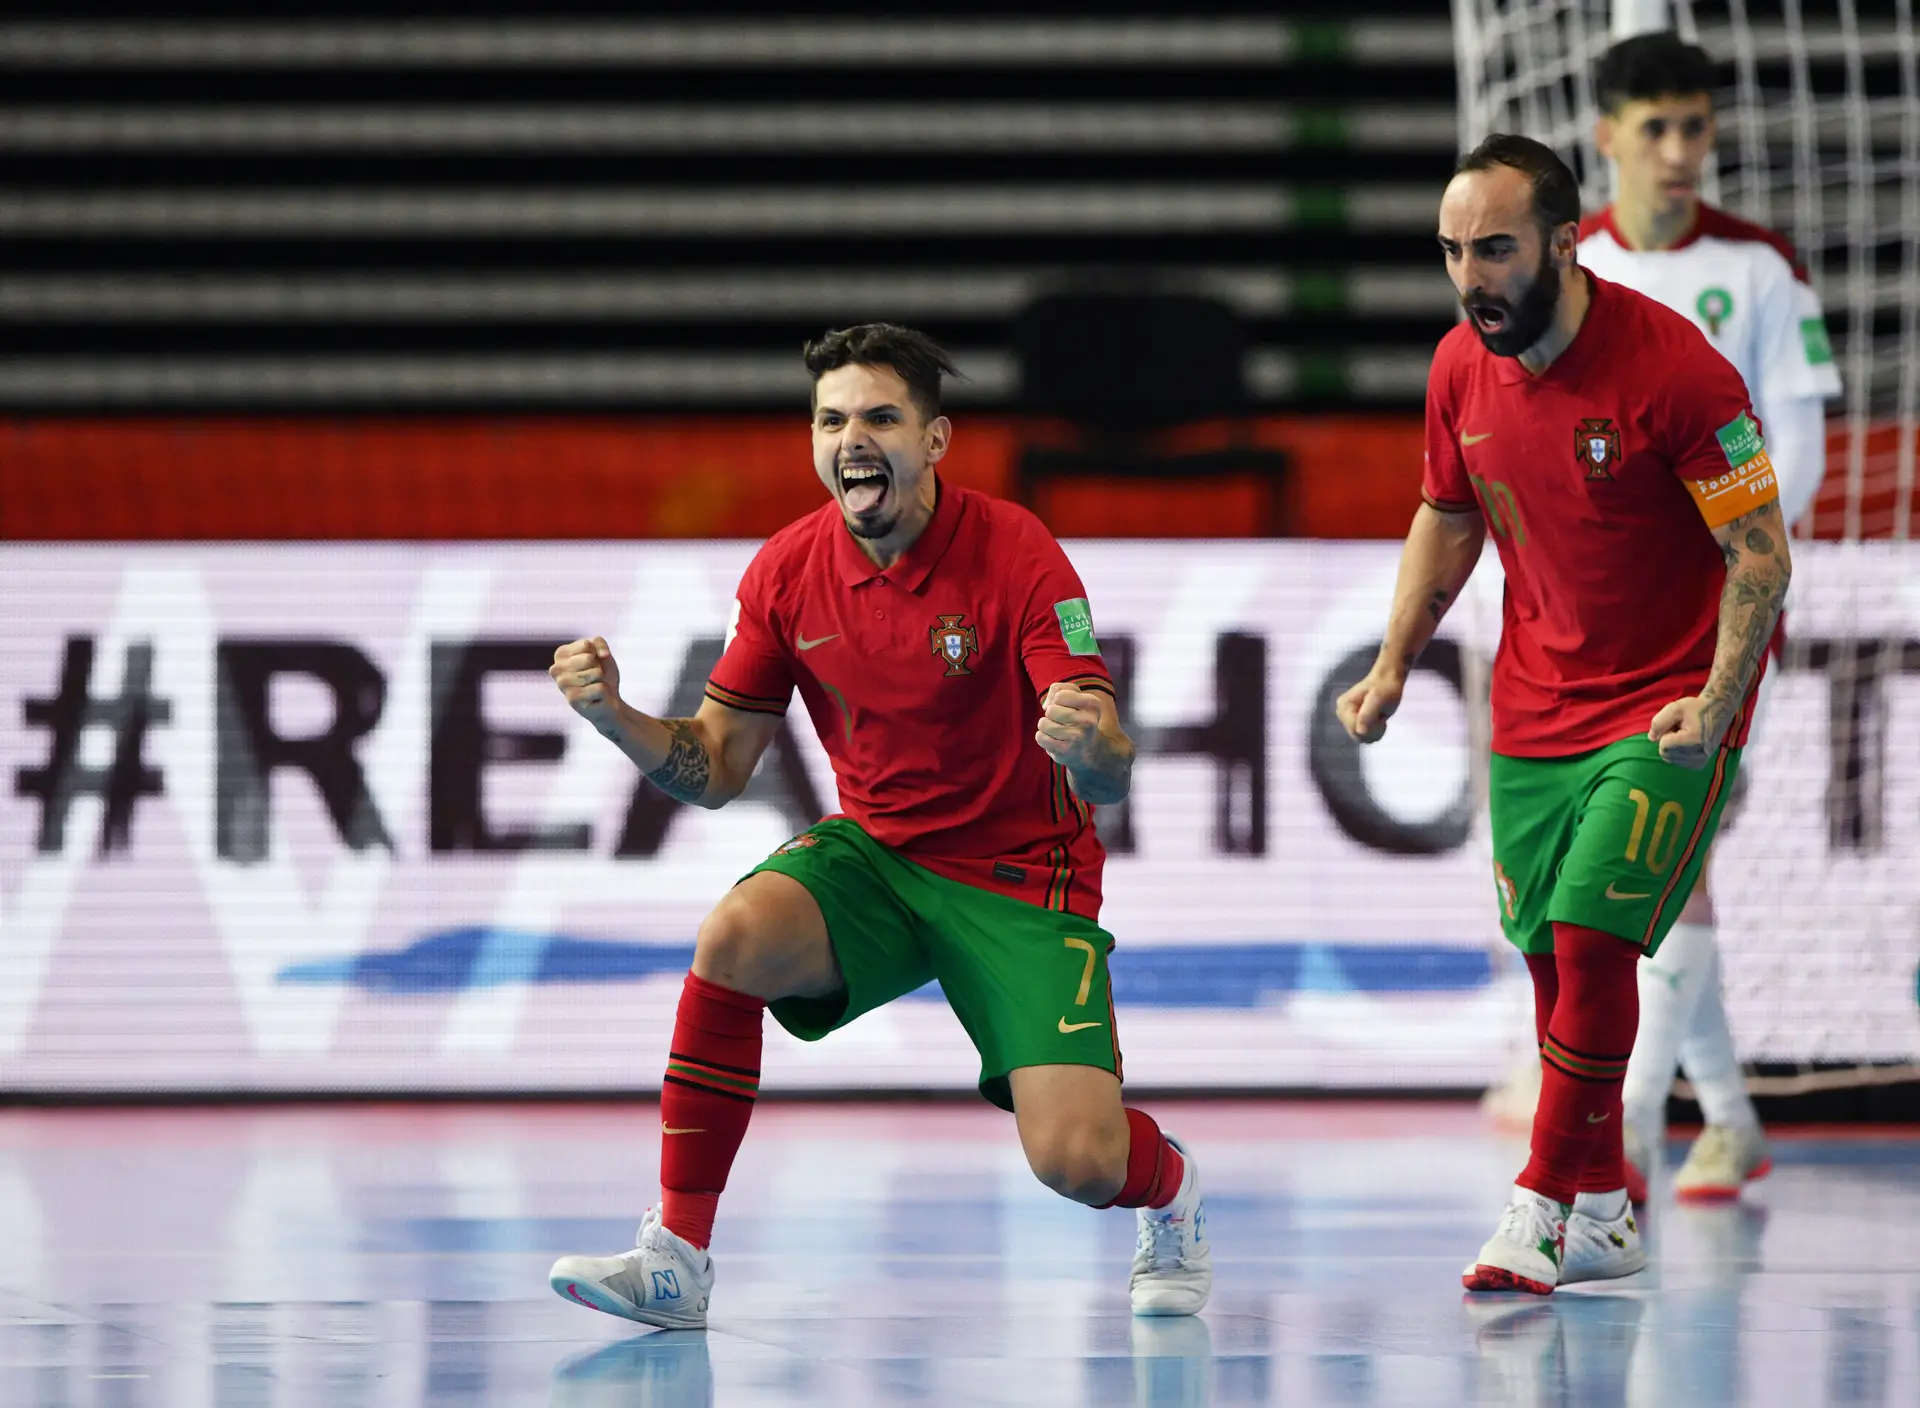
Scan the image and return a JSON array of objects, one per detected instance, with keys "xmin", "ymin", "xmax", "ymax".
[{"xmin": 1578, "ymin": 33, "xmax": 1839, "ymax": 1201}]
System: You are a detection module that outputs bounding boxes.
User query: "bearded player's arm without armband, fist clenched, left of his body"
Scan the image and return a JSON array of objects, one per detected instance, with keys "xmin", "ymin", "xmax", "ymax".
[{"xmin": 1334, "ymin": 503, "xmax": 1486, "ymax": 743}]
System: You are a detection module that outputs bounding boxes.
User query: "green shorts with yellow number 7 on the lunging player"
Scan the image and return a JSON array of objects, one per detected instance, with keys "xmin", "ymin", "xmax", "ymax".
[{"xmin": 749, "ymin": 816, "xmax": 1121, "ymax": 1110}]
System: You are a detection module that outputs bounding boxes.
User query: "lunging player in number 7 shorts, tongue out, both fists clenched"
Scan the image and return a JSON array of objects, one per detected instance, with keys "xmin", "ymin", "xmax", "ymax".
[{"xmin": 549, "ymin": 323, "xmax": 1213, "ymax": 1329}]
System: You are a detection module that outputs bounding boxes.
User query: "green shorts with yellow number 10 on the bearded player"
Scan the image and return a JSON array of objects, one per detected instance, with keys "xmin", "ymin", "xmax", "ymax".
[{"xmin": 1490, "ymin": 734, "xmax": 1740, "ymax": 955}]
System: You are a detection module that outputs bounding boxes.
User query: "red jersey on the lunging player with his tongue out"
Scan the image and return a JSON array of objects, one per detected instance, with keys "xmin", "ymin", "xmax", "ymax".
[{"xmin": 707, "ymin": 484, "xmax": 1114, "ymax": 918}]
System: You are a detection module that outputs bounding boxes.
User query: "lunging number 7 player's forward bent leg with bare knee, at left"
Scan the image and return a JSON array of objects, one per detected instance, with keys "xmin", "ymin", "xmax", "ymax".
[{"xmin": 547, "ymin": 872, "xmax": 841, "ymax": 1329}]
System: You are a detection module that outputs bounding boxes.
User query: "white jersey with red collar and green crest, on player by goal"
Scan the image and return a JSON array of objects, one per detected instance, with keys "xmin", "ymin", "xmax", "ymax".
[{"xmin": 1580, "ymin": 204, "xmax": 1839, "ymax": 405}]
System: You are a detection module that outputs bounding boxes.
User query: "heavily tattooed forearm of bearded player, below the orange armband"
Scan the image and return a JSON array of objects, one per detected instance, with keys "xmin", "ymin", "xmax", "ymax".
[{"xmin": 1647, "ymin": 499, "xmax": 1793, "ymax": 768}]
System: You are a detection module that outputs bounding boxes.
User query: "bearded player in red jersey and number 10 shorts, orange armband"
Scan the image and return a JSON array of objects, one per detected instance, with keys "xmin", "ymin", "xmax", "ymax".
[{"xmin": 1338, "ymin": 136, "xmax": 1791, "ymax": 1295}]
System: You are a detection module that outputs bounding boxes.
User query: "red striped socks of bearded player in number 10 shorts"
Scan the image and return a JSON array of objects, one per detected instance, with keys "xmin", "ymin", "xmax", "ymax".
[{"xmin": 1515, "ymin": 924, "xmax": 1640, "ymax": 1202}]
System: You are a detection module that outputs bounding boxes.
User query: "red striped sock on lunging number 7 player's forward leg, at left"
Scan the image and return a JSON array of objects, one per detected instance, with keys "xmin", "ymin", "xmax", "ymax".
[{"xmin": 660, "ymin": 974, "xmax": 766, "ymax": 1247}]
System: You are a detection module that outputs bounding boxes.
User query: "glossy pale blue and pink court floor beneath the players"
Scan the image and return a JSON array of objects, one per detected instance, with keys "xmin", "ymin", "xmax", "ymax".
[{"xmin": 0, "ymin": 1103, "xmax": 1920, "ymax": 1408}]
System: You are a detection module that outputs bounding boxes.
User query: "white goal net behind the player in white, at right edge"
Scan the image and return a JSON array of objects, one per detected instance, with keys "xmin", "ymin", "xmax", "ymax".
[{"xmin": 1453, "ymin": 0, "xmax": 1920, "ymax": 1093}]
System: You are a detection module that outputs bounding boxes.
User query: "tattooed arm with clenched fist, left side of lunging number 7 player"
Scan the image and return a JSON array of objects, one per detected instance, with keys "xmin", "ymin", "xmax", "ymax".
[{"xmin": 547, "ymin": 636, "xmax": 781, "ymax": 809}]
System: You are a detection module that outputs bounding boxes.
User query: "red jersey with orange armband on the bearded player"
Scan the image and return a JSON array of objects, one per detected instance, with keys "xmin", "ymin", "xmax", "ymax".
[{"xmin": 1423, "ymin": 275, "xmax": 1778, "ymax": 757}]
